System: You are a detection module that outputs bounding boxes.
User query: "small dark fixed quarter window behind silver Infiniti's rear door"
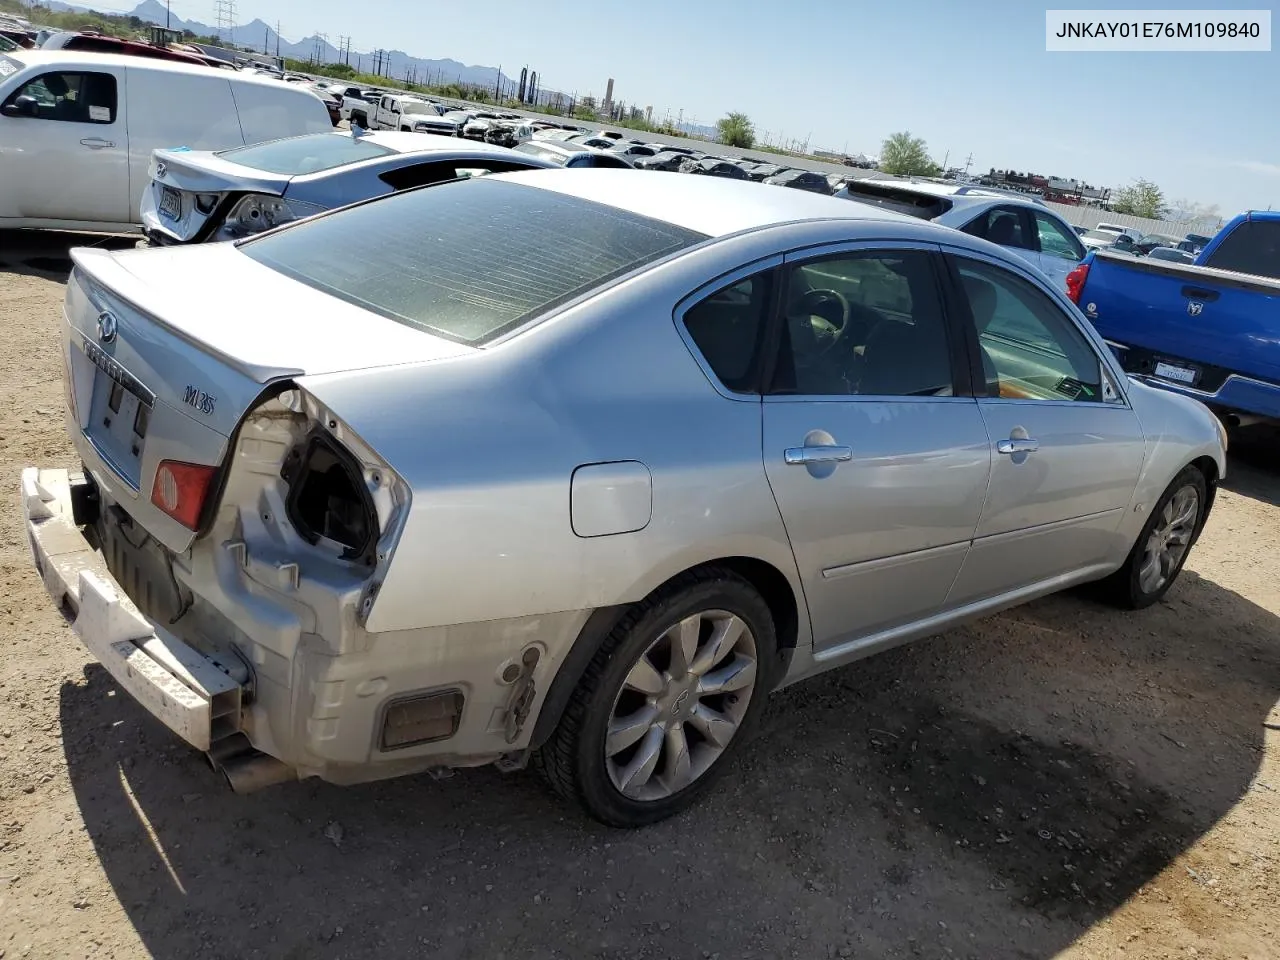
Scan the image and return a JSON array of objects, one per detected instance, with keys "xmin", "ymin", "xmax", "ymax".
[{"xmin": 684, "ymin": 273, "xmax": 772, "ymax": 393}]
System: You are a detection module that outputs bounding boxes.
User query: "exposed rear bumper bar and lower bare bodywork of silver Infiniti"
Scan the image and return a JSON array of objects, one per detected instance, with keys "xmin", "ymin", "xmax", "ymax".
[{"xmin": 22, "ymin": 467, "xmax": 590, "ymax": 790}]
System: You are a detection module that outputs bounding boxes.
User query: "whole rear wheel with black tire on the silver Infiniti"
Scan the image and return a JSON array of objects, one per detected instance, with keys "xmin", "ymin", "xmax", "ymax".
[{"xmin": 532, "ymin": 567, "xmax": 777, "ymax": 827}]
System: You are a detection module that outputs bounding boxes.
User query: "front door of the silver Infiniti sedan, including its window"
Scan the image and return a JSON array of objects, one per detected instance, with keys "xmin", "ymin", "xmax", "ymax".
[{"xmin": 951, "ymin": 257, "xmax": 1146, "ymax": 603}]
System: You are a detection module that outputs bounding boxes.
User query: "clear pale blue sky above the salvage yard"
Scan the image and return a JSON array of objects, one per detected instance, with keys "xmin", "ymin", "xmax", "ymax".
[{"xmin": 147, "ymin": 0, "xmax": 1280, "ymax": 216}]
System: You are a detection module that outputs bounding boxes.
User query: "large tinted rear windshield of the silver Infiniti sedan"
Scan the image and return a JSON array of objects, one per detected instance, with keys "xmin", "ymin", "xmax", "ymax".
[{"xmin": 239, "ymin": 174, "xmax": 705, "ymax": 346}]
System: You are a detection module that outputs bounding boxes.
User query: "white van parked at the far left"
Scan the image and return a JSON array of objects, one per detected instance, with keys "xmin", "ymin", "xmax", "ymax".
[{"xmin": 0, "ymin": 50, "xmax": 333, "ymax": 230}]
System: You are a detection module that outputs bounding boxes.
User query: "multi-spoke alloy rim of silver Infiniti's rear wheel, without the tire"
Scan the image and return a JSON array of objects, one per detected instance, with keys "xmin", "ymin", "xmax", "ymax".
[{"xmin": 604, "ymin": 609, "xmax": 758, "ymax": 801}]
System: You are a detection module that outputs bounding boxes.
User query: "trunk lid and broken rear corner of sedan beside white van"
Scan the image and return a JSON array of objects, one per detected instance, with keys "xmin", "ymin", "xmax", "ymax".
[{"xmin": 141, "ymin": 148, "xmax": 293, "ymax": 243}]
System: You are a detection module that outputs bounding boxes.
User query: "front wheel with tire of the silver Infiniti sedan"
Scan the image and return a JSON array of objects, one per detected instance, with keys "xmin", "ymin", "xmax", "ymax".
[{"xmin": 1100, "ymin": 467, "xmax": 1207, "ymax": 611}]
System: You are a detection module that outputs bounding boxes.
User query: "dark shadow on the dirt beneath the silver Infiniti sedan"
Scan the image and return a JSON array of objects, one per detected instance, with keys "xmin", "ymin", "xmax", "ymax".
[{"xmin": 61, "ymin": 571, "xmax": 1280, "ymax": 960}]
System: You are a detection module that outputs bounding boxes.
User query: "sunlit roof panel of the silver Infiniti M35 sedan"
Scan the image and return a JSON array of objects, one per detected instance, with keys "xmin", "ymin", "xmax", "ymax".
[{"xmin": 485, "ymin": 168, "xmax": 921, "ymax": 237}]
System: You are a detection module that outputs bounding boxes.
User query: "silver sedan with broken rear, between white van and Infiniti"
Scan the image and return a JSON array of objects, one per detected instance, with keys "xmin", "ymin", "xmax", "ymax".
[{"xmin": 140, "ymin": 131, "xmax": 556, "ymax": 247}]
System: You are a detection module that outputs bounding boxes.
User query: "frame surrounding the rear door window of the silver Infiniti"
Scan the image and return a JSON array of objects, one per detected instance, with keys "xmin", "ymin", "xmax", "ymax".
[{"xmin": 760, "ymin": 239, "xmax": 974, "ymax": 403}]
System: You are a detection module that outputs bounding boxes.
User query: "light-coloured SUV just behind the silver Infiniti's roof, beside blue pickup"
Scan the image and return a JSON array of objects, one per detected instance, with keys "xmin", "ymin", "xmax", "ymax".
[{"xmin": 836, "ymin": 179, "xmax": 1088, "ymax": 289}]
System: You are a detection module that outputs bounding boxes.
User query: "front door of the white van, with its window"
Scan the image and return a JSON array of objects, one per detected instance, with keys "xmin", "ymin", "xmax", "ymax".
[{"xmin": 0, "ymin": 69, "xmax": 127, "ymax": 223}]
